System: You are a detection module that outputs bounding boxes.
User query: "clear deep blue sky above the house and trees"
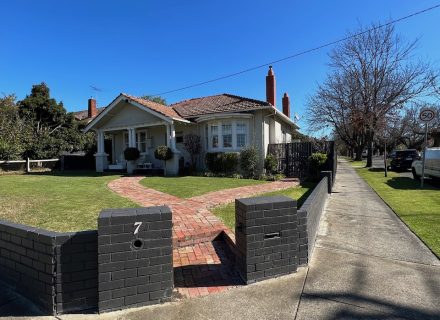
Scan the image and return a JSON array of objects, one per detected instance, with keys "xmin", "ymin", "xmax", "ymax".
[{"xmin": 0, "ymin": 0, "xmax": 440, "ymax": 132}]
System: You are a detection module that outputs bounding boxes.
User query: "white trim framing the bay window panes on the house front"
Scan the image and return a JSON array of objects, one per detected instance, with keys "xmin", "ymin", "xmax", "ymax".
[{"xmin": 207, "ymin": 119, "xmax": 250, "ymax": 152}]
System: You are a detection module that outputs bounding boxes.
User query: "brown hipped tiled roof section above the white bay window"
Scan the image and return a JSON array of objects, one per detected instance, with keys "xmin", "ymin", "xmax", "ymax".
[{"xmin": 171, "ymin": 93, "xmax": 272, "ymax": 118}]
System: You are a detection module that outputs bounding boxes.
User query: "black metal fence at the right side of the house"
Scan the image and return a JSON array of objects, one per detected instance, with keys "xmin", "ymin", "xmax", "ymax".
[{"xmin": 268, "ymin": 141, "xmax": 337, "ymax": 178}]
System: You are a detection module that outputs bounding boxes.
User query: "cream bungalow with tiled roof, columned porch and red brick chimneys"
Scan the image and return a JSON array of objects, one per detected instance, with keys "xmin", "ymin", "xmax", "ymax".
[{"xmin": 83, "ymin": 67, "xmax": 298, "ymax": 175}]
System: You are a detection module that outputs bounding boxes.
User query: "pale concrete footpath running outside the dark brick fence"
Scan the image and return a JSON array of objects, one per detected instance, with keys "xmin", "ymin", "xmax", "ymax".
[{"xmin": 0, "ymin": 162, "xmax": 440, "ymax": 320}]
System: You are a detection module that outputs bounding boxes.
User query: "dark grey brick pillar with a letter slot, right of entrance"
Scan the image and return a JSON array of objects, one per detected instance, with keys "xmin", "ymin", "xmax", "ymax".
[{"xmin": 235, "ymin": 196, "xmax": 298, "ymax": 284}]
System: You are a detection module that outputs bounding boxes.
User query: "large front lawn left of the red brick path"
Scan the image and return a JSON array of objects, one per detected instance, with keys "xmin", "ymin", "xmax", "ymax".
[{"xmin": 0, "ymin": 172, "xmax": 137, "ymax": 231}]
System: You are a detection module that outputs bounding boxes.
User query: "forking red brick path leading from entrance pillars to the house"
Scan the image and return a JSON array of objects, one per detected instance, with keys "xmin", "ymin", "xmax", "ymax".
[{"xmin": 108, "ymin": 177, "xmax": 298, "ymax": 297}]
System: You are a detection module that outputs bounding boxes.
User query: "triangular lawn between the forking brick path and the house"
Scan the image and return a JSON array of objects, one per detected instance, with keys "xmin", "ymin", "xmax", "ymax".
[{"xmin": 141, "ymin": 176, "xmax": 266, "ymax": 198}]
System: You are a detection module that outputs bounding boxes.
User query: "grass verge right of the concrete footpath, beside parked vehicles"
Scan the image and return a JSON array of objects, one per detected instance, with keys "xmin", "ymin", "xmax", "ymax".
[{"xmin": 356, "ymin": 168, "xmax": 440, "ymax": 257}]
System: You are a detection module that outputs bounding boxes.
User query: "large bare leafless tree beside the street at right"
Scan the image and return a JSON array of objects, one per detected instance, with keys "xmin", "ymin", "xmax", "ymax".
[{"xmin": 307, "ymin": 25, "xmax": 437, "ymax": 166}]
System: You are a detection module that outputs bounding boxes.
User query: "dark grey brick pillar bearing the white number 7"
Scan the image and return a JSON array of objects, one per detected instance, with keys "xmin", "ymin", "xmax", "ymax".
[{"xmin": 98, "ymin": 206, "xmax": 173, "ymax": 312}]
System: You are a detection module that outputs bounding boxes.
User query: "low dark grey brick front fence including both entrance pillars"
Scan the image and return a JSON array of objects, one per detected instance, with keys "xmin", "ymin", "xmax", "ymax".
[{"xmin": 0, "ymin": 172, "xmax": 333, "ymax": 315}]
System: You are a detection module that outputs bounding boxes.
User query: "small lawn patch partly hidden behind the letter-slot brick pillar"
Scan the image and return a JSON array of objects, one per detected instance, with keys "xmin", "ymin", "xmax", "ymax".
[{"xmin": 212, "ymin": 182, "xmax": 316, "ymax": 232}]
